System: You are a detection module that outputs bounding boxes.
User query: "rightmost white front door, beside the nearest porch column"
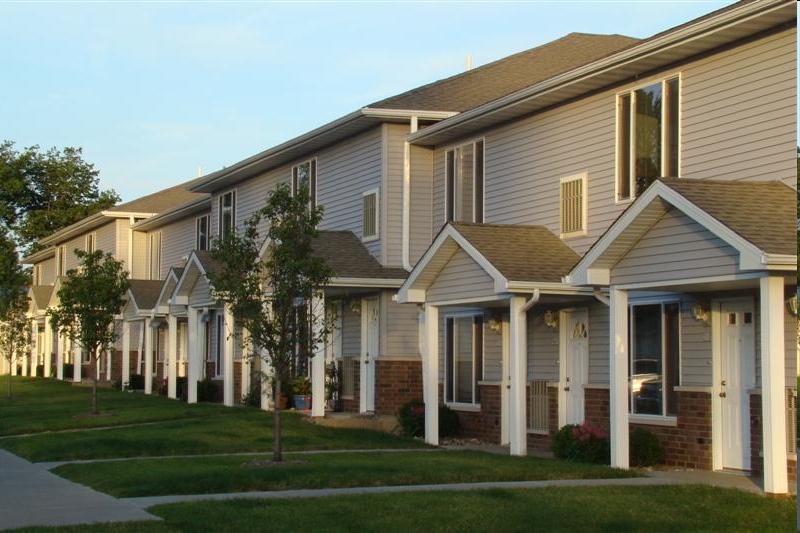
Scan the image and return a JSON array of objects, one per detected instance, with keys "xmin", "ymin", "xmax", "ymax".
[{"xmin": 716, "ymin": 301, "xmax": 755, "ymax": 470}]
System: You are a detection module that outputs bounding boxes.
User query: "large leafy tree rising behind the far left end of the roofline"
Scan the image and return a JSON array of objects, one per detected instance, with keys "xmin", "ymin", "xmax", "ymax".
[{"xmin": 0, "ymin": 141, "xmax": 119, "ymax": 254}]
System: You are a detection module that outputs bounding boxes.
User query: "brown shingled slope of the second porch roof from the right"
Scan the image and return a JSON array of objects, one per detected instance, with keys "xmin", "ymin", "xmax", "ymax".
[{"xmin": 452, "ymin": 223, "xmax": 580, "ymax": 283}]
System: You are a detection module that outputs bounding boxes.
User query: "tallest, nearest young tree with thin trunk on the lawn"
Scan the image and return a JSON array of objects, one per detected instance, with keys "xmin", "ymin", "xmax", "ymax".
[{"xmin": 208, "ymin": 185, "xmax": 330, "ymax": 461}]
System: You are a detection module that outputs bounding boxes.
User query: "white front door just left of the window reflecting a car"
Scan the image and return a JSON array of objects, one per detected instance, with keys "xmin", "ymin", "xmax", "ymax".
[{"xmin": 559, "ymin": 309, "xmax": 589, "ymax": 426}]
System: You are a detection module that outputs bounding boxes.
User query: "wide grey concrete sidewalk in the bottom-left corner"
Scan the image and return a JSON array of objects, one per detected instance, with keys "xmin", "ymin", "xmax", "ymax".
[{"xmin": 0, "ymin": 449, "xmax": 160, "ymax": 530}]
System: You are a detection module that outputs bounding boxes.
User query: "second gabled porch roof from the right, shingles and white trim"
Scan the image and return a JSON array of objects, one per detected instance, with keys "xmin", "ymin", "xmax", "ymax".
[{"xmin": 398, "ymin": 223, "xmax": 580, "ymax": 302}]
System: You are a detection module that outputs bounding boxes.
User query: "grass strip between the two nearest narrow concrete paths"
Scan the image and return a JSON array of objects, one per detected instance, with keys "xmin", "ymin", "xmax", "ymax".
[{"xmin": 54, "ymin": 451, "xmax": 636, "ymax": 497}]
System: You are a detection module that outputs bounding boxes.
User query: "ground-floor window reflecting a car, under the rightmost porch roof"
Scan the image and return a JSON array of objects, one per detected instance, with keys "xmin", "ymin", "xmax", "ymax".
[{"xmin": 629, "ymin": 302, "xmax": 680, "ymax": 416}]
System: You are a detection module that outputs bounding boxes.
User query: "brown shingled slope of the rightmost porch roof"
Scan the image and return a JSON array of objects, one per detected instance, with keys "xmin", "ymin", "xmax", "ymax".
[{"xmin": 661, "ymin": 178, "xmax": 797, "ymax": 255}]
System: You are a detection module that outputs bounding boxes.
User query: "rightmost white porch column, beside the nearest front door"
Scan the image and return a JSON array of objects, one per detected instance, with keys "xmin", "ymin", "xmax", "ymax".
[{"xmin": 760, "ymin": 276, "xmax": 789, "ymax": 494}]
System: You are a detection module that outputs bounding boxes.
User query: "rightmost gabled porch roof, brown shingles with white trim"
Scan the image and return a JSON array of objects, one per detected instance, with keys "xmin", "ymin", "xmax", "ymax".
[{"xmin": 569, "ymin": 178, "xmax": 797, "ymax": 286}]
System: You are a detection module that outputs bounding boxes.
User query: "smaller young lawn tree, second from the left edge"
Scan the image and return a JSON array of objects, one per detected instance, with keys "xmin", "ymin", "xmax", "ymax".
[{"xmin": 48, "ymin": 249, "xmax": 129, "ymax": 414}]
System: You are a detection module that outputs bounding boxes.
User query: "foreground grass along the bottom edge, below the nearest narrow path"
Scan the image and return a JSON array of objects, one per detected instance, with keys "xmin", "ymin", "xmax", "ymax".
[{"xmin": 15, "ymin": 486, "xmax": 796, "ymax": 533}]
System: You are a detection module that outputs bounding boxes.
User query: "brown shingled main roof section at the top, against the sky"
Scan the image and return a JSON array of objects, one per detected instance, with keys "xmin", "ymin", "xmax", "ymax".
[{"xmin": 367, "ymin": 33, "xmax": 639, "ymax": 112}]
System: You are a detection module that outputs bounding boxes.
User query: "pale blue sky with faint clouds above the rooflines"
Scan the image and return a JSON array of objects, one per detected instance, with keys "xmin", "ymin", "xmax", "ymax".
[{"xmin": 0, "ymin": 0, "xmax": 732, "ymax": 201}]
